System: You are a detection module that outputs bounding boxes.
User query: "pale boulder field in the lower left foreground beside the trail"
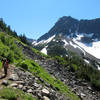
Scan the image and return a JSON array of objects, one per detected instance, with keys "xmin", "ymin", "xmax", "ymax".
[{"xmin": 2, "ymin": 66, "xmax": 67, "ymax": 100}]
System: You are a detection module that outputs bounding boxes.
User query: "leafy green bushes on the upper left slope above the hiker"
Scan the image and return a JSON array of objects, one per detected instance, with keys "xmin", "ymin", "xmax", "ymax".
[{"xmin": 0, "ymin": 33, "xmax": 23, "ymax": 63}]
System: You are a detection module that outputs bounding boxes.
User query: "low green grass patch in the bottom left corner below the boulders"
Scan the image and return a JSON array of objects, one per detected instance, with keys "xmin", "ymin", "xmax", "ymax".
[{"xmin": 0, "ymin": 88, "xmax": 37, "ymax": 100}]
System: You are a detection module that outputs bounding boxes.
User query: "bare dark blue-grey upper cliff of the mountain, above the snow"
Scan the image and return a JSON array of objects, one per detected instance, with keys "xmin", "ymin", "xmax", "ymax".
[{"xmin": 38, "ymin": 16, "xmax": 100, "ymax": 41}]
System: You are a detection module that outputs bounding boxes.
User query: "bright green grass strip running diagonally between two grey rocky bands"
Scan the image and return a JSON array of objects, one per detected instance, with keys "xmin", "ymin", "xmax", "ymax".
[{"xmin": 17, "ymin": 60, "xmax": 79, "ymax": 100}]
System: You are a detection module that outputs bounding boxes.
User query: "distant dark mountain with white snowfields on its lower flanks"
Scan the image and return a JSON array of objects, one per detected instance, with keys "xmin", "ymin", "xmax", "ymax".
[{"xmin": 33, "ymin": 16, "xmax": 100, "ymax": 61}]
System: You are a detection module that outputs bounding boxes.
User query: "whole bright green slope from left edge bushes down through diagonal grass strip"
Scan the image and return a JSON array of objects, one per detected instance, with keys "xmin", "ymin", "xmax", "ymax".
[{"xmin": 0, "ymin": 33, "xmax": 79, "ymax": 100}]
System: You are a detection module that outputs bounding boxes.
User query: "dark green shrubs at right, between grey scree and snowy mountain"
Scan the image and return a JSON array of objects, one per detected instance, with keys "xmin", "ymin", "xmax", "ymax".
[{"xmin": 57, "ymin": 52, "xmax": 100, "ymax": 89}]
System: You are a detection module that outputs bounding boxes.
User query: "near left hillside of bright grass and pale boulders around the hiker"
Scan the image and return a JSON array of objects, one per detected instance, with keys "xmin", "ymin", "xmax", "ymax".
[{"xmin": 0, "ymin": 32, "xmax": 80, "ymax": 100}]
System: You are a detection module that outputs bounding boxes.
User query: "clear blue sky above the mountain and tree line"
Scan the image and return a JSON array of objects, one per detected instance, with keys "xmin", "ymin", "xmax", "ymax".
[{"xmin": 0, "ymin": 0, "xmax": 100, "ymax": 39}]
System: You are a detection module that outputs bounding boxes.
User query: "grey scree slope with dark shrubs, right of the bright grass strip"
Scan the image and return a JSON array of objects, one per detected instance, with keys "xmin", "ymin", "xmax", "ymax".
[{"xmin": 19, "ymin": 34, "xmax": 100, "ymax": 100}]
